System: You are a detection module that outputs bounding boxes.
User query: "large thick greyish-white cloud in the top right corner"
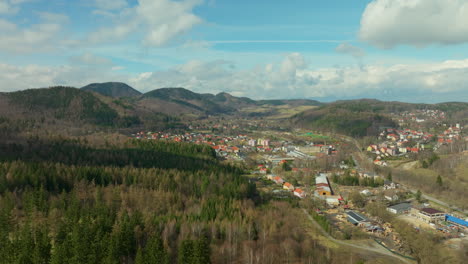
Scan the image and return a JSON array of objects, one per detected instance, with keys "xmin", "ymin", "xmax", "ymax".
[{"xmin": 359, "ymin": 0, "xmax": 468, "ymax": 48}]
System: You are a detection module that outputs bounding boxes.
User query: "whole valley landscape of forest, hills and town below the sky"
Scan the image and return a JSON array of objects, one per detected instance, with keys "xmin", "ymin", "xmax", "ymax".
[{"xmin": 0, "ymin": 83, "xmax": 468, "ymax": 263}]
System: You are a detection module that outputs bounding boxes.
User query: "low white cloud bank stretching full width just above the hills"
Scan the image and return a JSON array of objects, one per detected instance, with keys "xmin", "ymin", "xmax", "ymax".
[{"xmin": 0, "ymin": 53, "xmax": 468, "ymax": 102}]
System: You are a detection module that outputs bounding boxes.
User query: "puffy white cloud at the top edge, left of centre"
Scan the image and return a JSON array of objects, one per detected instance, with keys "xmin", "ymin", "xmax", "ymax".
[{"xmin": 89, "ymin": 0, "xmax": 202, "ymax": 47}]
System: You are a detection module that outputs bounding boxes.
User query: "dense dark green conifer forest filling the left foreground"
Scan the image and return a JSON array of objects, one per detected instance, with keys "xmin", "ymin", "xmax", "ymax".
[{"xmin": 0, "ymin": 139, "xmax": 257, "ymax": 263}]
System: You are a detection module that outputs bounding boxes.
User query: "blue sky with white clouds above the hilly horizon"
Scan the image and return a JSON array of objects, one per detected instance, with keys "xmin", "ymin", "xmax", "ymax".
[{"xmin": 0, "ymin": 0, "xmax": 468, "ymax": 103}]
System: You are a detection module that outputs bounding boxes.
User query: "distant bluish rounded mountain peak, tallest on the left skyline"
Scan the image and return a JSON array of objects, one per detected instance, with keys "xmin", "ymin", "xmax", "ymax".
[{"xmin": 81, "ymin": 82, "xmax": 141, "ymax": 98}]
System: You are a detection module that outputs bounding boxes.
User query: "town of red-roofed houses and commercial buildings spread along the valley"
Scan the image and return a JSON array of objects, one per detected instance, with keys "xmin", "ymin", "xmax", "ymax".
[{"xmin": 132, "ymin": 120, "xmax": 468, "ymax": 260}]
